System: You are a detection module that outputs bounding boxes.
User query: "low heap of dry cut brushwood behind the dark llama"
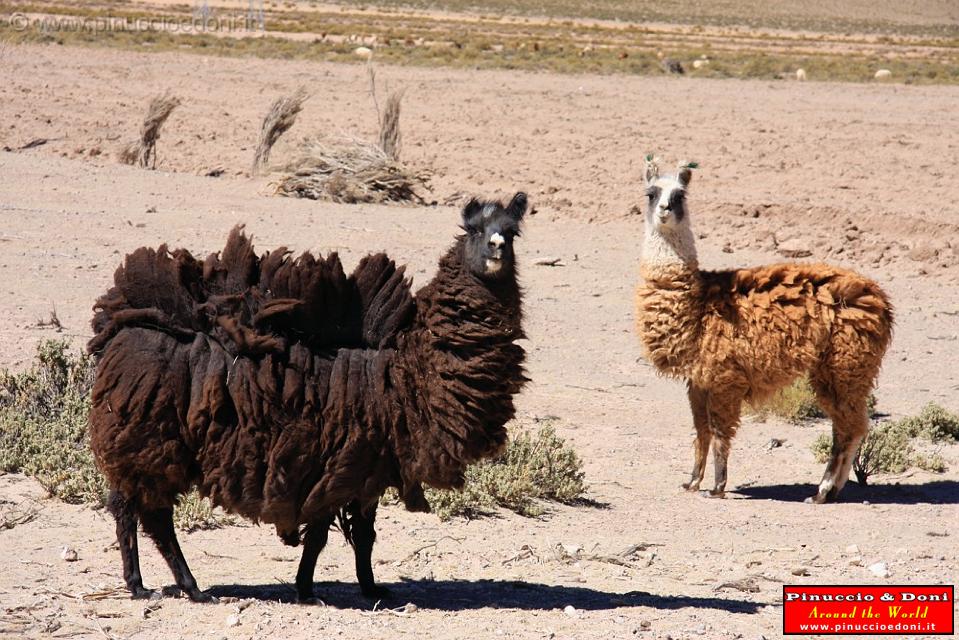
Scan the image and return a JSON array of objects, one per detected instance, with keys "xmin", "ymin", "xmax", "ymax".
[{"xmin": 276, "ymin": 138, "xmax": 428, "ymax": 204}]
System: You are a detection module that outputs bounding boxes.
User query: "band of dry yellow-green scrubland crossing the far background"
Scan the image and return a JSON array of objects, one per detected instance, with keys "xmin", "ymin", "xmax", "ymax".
[{"xmin": 0, "ymin": 0, "xmax": 959, "ymax": 84}]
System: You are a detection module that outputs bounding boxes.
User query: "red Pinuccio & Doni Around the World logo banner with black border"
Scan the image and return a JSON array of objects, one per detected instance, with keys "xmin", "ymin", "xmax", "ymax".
[{"xmin": 783, "ymin": 585, "xmax": 955, "ymax": 636}]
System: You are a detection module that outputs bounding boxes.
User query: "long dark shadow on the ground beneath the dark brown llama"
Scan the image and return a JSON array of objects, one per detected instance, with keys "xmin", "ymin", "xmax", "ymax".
[{"xmin": 207, "ymin": 580, "xmax": 767, "ymax": 613}]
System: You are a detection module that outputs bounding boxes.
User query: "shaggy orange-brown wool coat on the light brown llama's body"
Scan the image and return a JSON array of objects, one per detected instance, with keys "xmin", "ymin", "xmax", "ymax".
[{"xmin": 636, "ymin": 263, "xmax": 892, "ymax": 400}]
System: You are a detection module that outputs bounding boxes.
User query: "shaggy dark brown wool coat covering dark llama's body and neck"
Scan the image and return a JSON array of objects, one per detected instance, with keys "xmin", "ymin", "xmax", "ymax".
[{"xmin": 89, "ymin": 228, "xmax": 526, "ymax": 543}]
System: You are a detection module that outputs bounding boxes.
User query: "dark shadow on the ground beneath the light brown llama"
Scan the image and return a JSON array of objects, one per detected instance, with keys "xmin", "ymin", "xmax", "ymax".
[{"xmin": 730, "ymin": 480, "xmax": 959, "ymax": 504}]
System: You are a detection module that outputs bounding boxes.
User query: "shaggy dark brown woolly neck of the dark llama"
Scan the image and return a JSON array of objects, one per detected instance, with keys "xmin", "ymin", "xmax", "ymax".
[{"xmin": 399, "ymin": 239, "xmax": 526, "ymax": 487}]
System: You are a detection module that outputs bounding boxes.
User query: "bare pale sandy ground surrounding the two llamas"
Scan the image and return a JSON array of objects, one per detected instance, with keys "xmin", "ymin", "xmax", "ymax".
[{"xmin": 0, "ymin": 38, "xmax": 959, "ymax": 639}]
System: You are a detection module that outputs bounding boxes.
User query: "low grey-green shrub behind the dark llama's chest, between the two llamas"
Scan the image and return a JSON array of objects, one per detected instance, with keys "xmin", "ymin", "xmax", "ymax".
[{"xmin": 426, "ymin": 425, "xmax": 586, "ymax": 520}]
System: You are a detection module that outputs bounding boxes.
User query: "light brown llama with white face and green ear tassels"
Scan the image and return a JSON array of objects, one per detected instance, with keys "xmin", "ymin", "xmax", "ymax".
[{"xmin": 636, "ymin": 161, "xmax": 893, "ymax": 503}]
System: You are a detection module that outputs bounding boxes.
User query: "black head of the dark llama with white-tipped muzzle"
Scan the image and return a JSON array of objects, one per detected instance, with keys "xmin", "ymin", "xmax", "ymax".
[{"xmin": 463, "ymin": 192, "xmax": 526, "ymax": 280}]
